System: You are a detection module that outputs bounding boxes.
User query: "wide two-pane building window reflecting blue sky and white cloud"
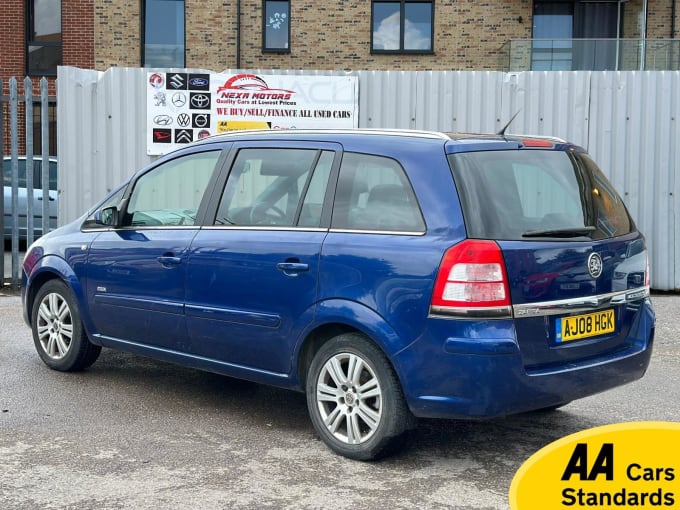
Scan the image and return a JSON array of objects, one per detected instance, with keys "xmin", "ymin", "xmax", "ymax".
[{"xmin": 371, "ymin": 0, "xmax": 434, "ymax": 53}]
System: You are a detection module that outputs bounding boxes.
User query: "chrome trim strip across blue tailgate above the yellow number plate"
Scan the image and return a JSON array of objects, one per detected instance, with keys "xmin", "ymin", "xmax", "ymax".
[{"xmin": 512, "ymin": 287, "xmax": 649, "ymax": 318}]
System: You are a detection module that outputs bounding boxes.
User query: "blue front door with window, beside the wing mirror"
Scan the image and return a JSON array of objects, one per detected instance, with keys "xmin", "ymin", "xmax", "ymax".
[{"xmin": 87, "ymin": 150, "xmax": 226, "ymax": 350}]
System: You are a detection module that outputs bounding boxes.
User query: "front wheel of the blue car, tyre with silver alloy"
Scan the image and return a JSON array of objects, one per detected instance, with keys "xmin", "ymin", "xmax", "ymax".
[{"xmin": 31, "ymin": 280, "xmax": 102, "ymax": 372}]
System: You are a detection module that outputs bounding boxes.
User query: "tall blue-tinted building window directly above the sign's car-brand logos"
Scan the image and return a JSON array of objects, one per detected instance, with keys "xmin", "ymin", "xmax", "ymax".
[{"xmin": 142, "ymin": 0, "xmax": 185, "ymax": 67}]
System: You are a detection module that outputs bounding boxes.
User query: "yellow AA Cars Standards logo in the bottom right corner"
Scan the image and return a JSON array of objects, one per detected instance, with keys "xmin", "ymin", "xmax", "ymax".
[{"xmin": 510, "ymin": 422, "xmax": 680, "ymax": 510}]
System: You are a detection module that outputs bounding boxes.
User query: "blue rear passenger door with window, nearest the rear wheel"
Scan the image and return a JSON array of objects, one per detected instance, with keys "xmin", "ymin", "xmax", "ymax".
[{"xmin": 186, "ymin": 142, "xmax": 340, "ymax": 373}]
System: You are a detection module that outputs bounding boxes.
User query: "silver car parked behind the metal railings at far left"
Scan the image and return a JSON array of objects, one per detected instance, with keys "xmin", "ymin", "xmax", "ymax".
[{"xmin": 2, "ymin": 156, "xmax": 57, "ymax": 241}]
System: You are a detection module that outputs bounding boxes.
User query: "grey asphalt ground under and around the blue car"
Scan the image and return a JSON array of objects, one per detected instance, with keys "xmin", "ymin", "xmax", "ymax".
[{"xmin": 0, "ymin": 295, "xmax": 680, "ymax": 510}]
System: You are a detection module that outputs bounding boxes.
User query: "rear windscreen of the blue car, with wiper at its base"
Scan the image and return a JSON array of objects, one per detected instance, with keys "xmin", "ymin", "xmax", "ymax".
[{"xmin": 449, "ymin": 150, "xmax": 634, "ymax": 240}]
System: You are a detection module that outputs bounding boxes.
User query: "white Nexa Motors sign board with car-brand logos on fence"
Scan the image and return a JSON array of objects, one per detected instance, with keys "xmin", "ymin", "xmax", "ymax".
[{"xmin": 146, "ymin": 72, "xmax": 359, "ymax": 155}]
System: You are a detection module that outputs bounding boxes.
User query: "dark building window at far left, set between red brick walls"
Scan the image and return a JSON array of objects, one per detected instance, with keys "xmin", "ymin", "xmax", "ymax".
[{"xmin": 26, "ymin": 0, "xmax": 62, "ymax": 76}]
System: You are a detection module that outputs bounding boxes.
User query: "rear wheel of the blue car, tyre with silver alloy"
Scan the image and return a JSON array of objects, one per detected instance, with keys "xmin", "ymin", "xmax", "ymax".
[{"xmin": 306, "ymin": 333, "xmax": 416, "ymax": 460}]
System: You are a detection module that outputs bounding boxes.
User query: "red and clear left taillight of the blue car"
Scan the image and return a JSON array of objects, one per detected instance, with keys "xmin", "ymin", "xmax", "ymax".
[{"xmin": 431, "ymin": 239, "xmax": 510, "ymax": 312}]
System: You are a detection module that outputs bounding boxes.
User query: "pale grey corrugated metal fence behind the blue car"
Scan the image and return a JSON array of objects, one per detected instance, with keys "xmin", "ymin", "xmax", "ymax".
[{"xmin": 27, "ymin": 67, "xmax": 680, "ymax": 290}]
